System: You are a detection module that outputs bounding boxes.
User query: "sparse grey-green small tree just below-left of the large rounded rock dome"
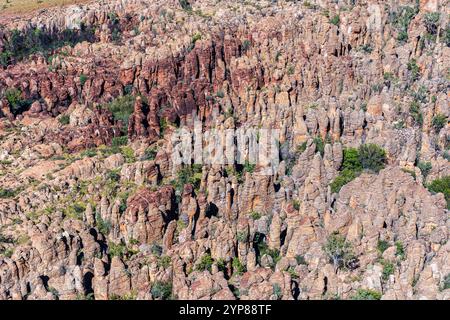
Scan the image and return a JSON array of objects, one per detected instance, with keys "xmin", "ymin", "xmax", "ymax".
[{"xmin": 322, "ymin": 232, "xmax": 355, "ymax": 273}]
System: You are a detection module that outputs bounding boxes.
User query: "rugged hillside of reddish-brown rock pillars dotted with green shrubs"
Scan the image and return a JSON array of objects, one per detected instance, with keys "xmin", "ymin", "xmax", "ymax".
[{"xmin": 0, "ymin": 0, "xmax": 450, "ymax": 300}]
